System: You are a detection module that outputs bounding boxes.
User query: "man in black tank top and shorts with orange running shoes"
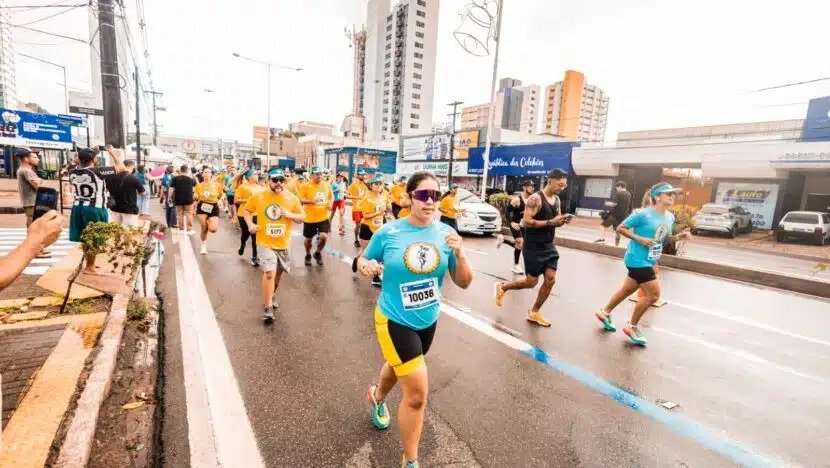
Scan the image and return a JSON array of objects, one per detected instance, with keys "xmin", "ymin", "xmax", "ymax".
[{"xmin": 496, "ymin": 169, "xmax": 572, "ymax": 327}]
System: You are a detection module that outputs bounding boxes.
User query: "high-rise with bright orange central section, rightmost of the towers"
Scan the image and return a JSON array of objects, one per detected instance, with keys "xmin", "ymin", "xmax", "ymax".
[{"xmin": 544, "ymin": 70, "xmax": 609, "ymax": 142}]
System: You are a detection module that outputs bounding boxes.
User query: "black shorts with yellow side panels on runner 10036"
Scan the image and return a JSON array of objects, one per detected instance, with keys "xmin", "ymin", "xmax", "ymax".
[{"xmin": 375, "ymin": 308, "xmax": 438, "ymax": 377}]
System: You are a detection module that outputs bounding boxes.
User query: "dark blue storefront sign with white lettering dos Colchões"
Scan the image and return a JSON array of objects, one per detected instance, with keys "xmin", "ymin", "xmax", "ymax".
[{"xmin": 467, "ymin": 143, "xmax": 574, "ymax": 176}]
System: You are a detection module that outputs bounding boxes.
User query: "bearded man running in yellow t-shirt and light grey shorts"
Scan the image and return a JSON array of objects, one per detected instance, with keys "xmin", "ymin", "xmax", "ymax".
[{"xmin": 244, "ymin": 169, "xmax": 305, "ymax": 324}]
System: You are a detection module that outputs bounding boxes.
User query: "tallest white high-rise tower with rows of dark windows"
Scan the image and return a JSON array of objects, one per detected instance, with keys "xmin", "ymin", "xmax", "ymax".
[{"xmin": 362, "ymin": 0, "xmax": 440, "ymax": 139}]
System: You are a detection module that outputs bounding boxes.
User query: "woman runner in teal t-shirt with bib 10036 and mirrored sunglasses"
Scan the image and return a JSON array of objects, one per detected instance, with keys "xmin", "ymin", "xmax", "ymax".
[{"xmin": 358, "ymin": 172, "xmax": 473, "ymax": 467}]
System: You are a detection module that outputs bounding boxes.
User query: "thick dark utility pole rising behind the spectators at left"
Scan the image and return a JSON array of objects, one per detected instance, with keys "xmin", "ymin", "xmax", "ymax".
[{"xmin": 98, "ymin": 0, "xmax": 125, "ymax": 148}]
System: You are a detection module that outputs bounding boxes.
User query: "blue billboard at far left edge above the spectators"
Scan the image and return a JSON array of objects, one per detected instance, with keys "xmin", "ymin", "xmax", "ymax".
[{"xmin": 0, "ymin": 107, "xmax": 72, "ymax": 149}]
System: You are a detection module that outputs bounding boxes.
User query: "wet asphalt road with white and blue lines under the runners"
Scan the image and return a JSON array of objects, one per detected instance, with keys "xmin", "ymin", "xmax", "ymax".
[{"xmin": 159, "ymin": 219, "xmax": 830, "ymax": 467}]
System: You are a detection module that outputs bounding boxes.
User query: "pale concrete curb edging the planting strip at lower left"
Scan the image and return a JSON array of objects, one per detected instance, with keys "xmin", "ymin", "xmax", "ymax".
[{"xmin": 54, "ymin": 227, "xmax": 146, "ymax": 468}]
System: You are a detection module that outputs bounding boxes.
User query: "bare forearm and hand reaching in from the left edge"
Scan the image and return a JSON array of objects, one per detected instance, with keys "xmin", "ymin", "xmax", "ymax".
[{"xmin": 0, "ymin": 210, "xmax": 63, "ymax": 291}]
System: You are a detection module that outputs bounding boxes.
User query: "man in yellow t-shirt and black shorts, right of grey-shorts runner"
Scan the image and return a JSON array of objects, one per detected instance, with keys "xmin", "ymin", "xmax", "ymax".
[{"xmin": 300, "ymin": 166, "xmax": 334, "ymax": 266}]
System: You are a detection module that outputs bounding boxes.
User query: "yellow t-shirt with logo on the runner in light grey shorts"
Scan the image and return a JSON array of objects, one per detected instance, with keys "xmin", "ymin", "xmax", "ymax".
[{"xmin": 243, "ymin": 190, "xmax": 303, "ymax": 250}]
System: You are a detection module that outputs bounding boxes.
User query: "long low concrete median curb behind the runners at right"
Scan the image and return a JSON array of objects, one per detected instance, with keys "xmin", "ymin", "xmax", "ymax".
[{"xmin": 556, "ymin": 237, "xmax": 830, "ymax": 299}]
